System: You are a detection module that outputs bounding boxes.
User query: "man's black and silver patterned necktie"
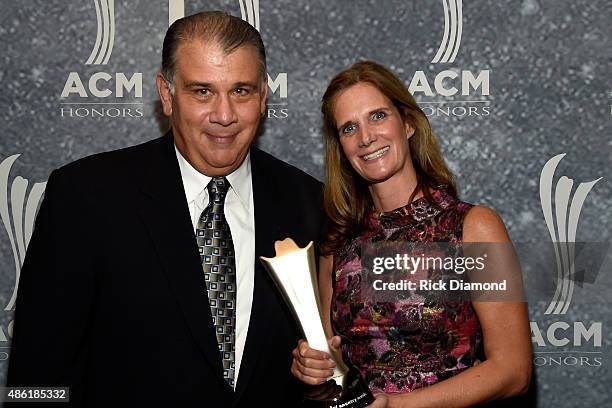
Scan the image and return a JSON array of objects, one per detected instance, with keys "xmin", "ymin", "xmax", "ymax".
[{"xmin": 196, "ymin": 177, "xmax": 236, "ymax": 388}]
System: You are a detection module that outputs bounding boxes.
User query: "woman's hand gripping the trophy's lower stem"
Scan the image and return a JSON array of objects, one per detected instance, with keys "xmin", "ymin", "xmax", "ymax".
[{"xmin": 291, "ymin": 336, "xmax": 340, "ymax": 385}]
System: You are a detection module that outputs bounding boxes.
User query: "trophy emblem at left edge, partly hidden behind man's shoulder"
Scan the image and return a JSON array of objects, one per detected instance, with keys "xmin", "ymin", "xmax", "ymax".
[{"xmin": 0, "ymin": 154, "xmax": 47, "ymax": 361}]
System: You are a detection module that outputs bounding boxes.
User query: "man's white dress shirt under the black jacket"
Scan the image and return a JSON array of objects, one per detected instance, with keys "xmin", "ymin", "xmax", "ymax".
[{"xmin": 174, "ymin": 146, "xmax": 255, "ymax": 389}]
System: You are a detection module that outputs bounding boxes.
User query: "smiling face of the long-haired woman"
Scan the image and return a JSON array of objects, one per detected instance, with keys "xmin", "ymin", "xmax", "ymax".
[{"xmin": 333, "ymin": 82, "xmax": 414, "ymax": 183}]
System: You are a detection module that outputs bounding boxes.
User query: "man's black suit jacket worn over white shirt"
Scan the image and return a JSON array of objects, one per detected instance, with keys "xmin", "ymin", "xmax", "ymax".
[{"xmin": 7, "ymin": 133, "xmax": 323, "ymax": 408}]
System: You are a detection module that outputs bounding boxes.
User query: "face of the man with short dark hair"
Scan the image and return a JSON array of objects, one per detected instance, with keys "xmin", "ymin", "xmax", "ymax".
[{"xmin": 157, "ymin": 40, "xmax": 267, "ymax": 176}]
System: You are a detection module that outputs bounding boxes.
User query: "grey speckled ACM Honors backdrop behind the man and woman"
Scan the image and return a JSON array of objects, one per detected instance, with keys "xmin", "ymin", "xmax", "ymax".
[{"xmin": 0, "ymin": 0, "xmax": 612, "ymax": 407}]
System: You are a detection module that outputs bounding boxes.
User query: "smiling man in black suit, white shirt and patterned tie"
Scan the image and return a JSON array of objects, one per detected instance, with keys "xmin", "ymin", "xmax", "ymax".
[{"xmin": 8, "ymin": 12, "xmax": 322, "ymax": 407}]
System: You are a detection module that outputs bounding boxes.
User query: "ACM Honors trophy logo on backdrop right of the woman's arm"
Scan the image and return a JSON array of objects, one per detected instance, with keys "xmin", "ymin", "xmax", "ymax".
[{"xmin": 530, "ymin": 153, "xmax": 603, "ymax": 367}]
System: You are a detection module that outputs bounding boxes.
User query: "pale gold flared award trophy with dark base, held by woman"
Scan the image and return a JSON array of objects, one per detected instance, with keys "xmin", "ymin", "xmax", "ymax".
[{"xmin": 260, "ymin": 238, "xmax": 374, "ymax": 408}]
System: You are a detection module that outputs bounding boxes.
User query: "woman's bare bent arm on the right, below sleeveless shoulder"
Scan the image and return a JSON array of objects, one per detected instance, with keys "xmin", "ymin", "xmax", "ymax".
[{"xmin": 387, "ymin": 207, "xmax": 531, "ymax": 408}]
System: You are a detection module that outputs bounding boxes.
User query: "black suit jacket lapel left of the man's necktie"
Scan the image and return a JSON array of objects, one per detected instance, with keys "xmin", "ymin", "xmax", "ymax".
[{"xmin": 139, "ymin": 133, "xmax": 227, "ymax": 386}]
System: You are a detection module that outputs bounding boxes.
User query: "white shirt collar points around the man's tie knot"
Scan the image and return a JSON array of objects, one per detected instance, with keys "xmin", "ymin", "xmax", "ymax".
[{"xmin": 174, "ymin": 145, "xmax": 252, "ymax": 210}]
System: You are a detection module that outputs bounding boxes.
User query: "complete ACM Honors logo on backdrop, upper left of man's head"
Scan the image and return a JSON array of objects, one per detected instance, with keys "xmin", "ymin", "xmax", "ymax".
[{"xmin": 60, "ymin": 0, "xmax": 143, "ymax": 118}]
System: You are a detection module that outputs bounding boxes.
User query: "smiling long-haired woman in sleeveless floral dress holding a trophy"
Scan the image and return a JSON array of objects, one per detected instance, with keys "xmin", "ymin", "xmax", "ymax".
[{"xmin": 291, "ymin": 62, "xmax": 531, "ymax": 408}]
